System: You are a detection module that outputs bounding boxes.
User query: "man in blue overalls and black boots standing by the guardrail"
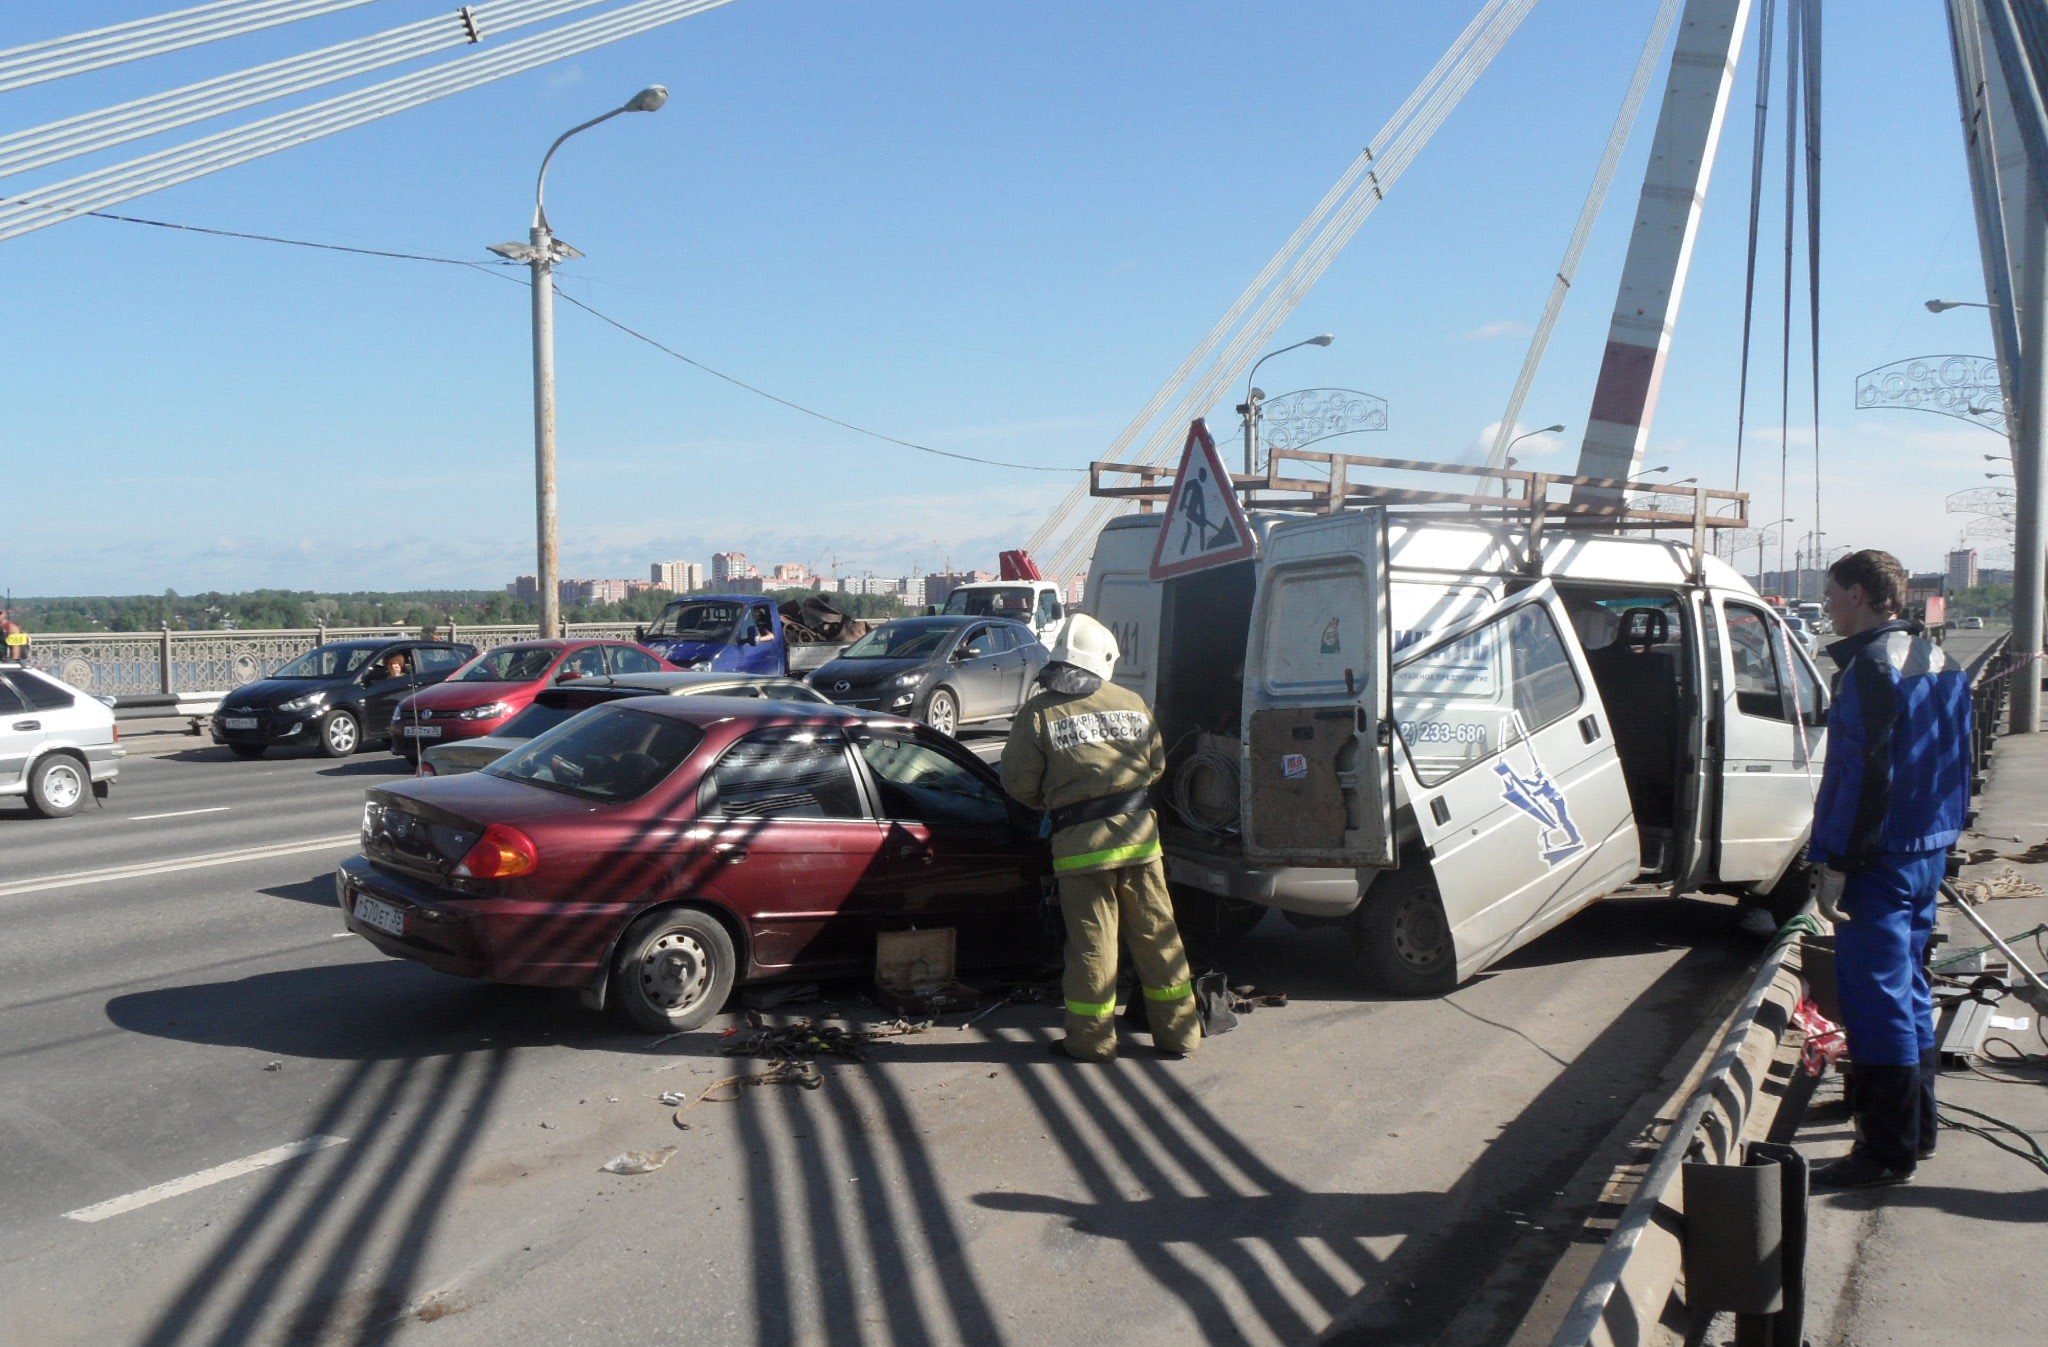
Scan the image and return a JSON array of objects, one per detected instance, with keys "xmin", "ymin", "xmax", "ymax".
[{"xmin": 1808, "ymin": 551, "xmax": 1974, "ymax": 1187}]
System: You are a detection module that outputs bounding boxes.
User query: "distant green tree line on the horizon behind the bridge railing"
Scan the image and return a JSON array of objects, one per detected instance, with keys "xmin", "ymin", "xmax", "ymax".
[{"xmin": 8, "ymin": 590, "xmax": 907, "ymax": 633}]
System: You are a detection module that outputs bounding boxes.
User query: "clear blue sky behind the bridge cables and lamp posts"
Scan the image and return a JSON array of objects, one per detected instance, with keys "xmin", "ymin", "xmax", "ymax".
[{"xmin": 0, "ymin": 0, "xmax": 2005, "ymax": 594}]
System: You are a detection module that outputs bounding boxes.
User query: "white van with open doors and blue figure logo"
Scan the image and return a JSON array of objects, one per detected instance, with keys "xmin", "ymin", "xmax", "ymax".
[{"xmin": 1083, "ymin": 506, "xmax": 1827, "ymax": 995}]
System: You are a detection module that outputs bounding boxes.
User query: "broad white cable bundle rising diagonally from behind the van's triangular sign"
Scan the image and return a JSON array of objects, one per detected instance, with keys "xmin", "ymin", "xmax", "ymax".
[{"xmin": 1030, "ymin": 0, "xmax": 1536, "ymax": 575}]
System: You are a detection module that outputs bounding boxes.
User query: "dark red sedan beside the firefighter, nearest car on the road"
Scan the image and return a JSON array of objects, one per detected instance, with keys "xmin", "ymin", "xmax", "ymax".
[{"xmin": 334, "ymin": 696, "xmax": 1057, "ymax": 1032}]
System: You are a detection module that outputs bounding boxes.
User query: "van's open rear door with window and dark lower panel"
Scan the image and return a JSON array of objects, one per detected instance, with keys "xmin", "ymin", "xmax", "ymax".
[{"xmin": 1239, "ymin": 508, "xmax": 1397, "ymax": 868}]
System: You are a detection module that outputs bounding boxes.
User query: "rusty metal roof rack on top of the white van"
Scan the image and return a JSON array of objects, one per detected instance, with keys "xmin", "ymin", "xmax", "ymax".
[{"xmin": 1087, "ymin": 448, "xmax": 1749, "ymax": 553}]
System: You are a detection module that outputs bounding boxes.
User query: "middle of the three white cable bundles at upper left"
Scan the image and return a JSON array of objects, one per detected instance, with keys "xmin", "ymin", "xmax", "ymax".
[{"xmin": 0, "ymin": 0, "xmax": 602, "ymax": 176}]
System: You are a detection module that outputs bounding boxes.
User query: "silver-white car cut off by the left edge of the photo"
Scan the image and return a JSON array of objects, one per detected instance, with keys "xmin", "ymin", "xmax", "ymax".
[{"xmin": 0, "ymin": 663, "xmax": 127, "ymax": 819}]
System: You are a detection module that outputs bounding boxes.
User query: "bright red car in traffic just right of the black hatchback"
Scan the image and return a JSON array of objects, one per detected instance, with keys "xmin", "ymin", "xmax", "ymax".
[{"xmin": 391, "ymin": 641, "xmax": 676, "ymax": 759}]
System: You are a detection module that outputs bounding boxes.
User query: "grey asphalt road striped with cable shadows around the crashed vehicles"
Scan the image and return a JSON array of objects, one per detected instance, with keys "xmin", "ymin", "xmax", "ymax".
[{"xmin": 0, "ymin": 724, "xmax": 1761, "ymax": 1347}]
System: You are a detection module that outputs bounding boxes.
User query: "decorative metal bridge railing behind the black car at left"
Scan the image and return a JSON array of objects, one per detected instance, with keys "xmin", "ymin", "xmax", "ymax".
[{"xmin": 12, "ymin": 622, "xmax": 633, "ymax": 696}]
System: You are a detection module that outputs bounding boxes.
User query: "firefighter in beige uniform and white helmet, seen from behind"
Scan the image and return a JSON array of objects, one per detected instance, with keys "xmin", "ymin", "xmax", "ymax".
[{"xmin": 1004, "ymin": 614, "xmax": 1202, "ymax": 1062}]
